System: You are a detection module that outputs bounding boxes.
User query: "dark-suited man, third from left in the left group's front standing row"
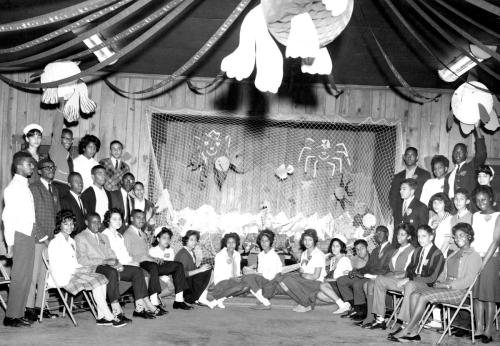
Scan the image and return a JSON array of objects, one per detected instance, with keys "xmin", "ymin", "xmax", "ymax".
[{"xmin": 61, "ymin": 172, "xmax": 87, "ymax": 237}]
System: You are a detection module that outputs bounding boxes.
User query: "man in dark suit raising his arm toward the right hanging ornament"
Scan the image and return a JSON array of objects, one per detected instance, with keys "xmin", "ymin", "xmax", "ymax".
[{"xmin": 444, "ymin": 127, "xmax": 487, "ymax": 199}]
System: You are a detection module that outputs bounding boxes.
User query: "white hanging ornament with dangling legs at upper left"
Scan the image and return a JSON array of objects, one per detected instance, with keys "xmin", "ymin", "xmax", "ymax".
[{"xmin": 40, "ymin": 61, "xmax": 97, "ymax": 122}]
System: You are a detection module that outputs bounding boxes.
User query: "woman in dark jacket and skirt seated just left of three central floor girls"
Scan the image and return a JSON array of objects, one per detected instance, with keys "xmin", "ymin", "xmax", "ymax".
[{"xmin": 174, "ymin": 230, "xmax": 212, "ymax": 306}]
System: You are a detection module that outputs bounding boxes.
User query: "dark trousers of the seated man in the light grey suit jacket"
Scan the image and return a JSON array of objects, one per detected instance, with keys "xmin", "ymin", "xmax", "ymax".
[{"xmin": 95, "ymin": 265, "xmax": 148, "ymax": 303}]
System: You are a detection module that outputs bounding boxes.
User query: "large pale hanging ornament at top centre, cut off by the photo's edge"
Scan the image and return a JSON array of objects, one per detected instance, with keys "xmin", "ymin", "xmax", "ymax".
[{"xmin": 221, "ymin": 0, "xmax": 354, "ymax": 93}]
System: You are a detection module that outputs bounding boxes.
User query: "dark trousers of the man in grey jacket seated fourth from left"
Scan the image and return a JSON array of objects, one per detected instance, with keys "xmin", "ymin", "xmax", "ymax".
[{"xmin": 140, "ymin": 261, "xmax": 186, "ymax": 295}]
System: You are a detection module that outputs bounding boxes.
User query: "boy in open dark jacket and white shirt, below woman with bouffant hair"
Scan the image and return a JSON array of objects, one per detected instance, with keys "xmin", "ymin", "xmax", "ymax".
[{"xmin": 81, "ymin": 165, "xmax": 111, "ymax": 220}]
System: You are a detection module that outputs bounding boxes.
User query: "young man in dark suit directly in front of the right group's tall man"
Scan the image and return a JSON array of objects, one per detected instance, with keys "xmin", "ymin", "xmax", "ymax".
[{"xmin": 392, "ymin": 179, "xmax": 429, "ymax": 246}]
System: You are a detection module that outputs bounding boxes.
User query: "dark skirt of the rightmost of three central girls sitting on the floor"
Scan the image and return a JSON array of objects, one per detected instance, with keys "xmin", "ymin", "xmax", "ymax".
[{"xmin": 278, "ymin": 273, "xmax": 321, "ymax": 306}]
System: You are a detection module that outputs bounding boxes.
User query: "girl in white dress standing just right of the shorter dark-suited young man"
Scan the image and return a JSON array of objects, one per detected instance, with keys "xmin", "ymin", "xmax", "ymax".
[{"xmin": 429, "ymin": 192, "xmax": 453, "ymax": 258}]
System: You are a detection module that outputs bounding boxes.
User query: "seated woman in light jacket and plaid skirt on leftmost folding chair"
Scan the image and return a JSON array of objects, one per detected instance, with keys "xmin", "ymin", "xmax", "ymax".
[{"xmin": 48, "ymin": 209, "xmax": 127, "ymax": 327}]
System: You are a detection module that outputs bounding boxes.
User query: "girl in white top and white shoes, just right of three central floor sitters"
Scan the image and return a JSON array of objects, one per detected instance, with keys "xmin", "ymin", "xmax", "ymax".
[{"xmin": 318, "ymin": 234, "xmax": 352, "ymax": 314}]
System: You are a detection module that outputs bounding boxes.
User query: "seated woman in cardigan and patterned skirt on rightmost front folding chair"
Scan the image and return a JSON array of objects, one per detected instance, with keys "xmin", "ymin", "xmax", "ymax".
[{"xmin": 388, "ymin": 223, "xmax": 481, "ymax": 342}]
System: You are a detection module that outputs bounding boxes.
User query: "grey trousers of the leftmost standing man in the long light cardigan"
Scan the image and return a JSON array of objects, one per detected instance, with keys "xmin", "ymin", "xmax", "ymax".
[{"xmin": 5, "ymin": 232, "xmax": 35, "ymax": 318}]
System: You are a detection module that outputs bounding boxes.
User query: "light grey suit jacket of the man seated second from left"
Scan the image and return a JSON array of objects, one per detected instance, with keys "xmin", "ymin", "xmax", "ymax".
[{"xmin": 75, "ymin": 228, "xmax": 116, "ymax": 267}]
